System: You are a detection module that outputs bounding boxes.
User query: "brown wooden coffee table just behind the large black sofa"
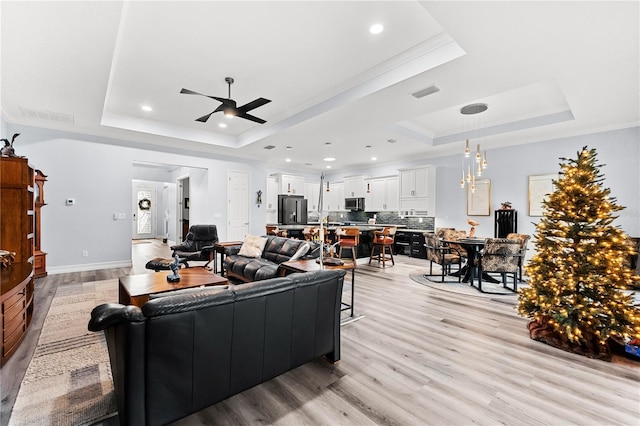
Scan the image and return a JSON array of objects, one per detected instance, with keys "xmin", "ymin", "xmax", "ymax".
[{"xmin": 119, "ymin": 267, "xmax": 229, "ymax": 307}]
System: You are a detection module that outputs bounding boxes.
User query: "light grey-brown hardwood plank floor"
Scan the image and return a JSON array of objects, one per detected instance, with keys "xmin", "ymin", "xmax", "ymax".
[{"xmin": 2, "ymin": 240, "xmax": 640, "ymax": 425}]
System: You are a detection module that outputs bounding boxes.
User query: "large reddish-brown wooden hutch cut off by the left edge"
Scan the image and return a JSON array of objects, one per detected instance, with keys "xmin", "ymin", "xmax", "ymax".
[{"xmin": 0, "ymin": 157, "xmax": 35, "ymax": 364}]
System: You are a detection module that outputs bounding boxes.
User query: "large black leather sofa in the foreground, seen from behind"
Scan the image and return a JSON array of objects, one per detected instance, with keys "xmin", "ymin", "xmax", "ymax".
[{"xmin": 89, "ymin": 270, "xmax": 345, "ymax": 425}]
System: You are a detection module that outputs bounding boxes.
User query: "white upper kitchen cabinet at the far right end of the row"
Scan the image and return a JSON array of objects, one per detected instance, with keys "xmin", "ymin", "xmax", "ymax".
[{"xmin": 399, "ymin": 166, "xmax": 436, "ymax": 216}]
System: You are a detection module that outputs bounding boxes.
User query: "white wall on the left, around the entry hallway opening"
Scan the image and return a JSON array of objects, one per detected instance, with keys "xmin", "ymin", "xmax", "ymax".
[{"xmin": 12, "ymin": 125, "xmax": 266, "ymax": 274}]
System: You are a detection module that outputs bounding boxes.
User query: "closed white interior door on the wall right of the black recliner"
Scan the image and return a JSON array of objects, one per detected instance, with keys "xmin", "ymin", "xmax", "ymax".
[{"xmin": 227, "ymin": 172, "xmax": 249, "ymax": 241}]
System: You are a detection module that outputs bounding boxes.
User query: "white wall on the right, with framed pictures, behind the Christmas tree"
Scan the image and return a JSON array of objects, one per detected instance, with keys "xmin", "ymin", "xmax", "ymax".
[{"xmin": 328, "ymin": 127, "xmax": 640, "ymax": 237}]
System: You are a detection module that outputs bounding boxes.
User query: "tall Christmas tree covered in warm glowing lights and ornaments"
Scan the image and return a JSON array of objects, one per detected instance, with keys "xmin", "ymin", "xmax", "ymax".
[{"xmin": 518, "ymin": 147, "xmax": 640, "ymax": 360}]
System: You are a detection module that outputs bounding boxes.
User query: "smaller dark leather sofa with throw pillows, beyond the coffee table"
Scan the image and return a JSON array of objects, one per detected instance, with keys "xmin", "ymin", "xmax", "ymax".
[{"xmin": 224, "ymin": 235, "xmax": 320, "ymax": 282}]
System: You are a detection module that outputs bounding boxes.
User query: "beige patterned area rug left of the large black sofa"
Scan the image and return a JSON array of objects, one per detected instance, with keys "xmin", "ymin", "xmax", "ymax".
[{"xmin": 9, "ymin": 279, "xmax": 118, "ymax": 426}]
